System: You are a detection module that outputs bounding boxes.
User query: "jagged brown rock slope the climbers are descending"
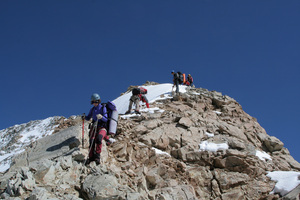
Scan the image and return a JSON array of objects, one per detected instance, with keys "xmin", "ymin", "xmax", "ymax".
[{"xmin": 0, "ymin": 88, "xmax": 300, "ymax": 200}]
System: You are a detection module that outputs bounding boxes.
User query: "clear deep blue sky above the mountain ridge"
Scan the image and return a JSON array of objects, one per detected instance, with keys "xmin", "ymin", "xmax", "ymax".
[{"xmin": 0, "ymin": 0, "xmax": 300, "ymax": 161}]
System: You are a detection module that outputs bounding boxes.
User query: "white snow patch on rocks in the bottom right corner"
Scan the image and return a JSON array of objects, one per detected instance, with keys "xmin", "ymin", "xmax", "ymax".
[{"xmin": 267, "ymin": 171, "xmax": 300, "ymax": 196}]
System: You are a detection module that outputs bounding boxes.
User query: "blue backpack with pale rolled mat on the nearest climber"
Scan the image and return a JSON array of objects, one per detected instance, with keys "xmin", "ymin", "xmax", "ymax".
[{"xmin": 101, "ymin": 101, "xmax": 118, "ymax": 134}]
